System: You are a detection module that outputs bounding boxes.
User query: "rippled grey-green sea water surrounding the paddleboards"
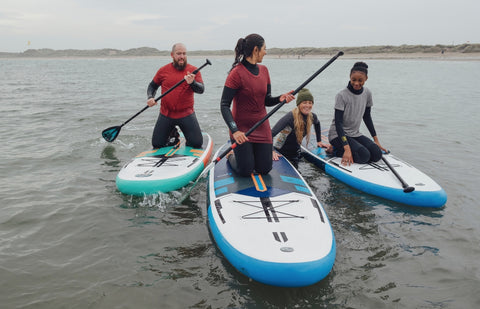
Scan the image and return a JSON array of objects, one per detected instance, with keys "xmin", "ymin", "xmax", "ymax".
[{"xmin": 0, "ymin": 55, "xmax": 480, "ymax": 308}]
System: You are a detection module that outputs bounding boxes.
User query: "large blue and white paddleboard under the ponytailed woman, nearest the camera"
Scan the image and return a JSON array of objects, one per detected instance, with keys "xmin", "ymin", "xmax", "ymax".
[{"xmin": 208, "ymin": 144, "xmax": 336, "ymax": 287}]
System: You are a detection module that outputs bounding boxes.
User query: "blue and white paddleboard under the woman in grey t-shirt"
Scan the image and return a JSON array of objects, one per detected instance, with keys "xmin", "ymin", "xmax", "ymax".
[{"xmin": 302, "ymin": 133, "xmax": 447, "ymax": 207}]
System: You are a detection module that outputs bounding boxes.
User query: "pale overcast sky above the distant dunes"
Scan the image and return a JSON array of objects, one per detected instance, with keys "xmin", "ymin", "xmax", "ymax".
[{"xmin": 0, "ymin": 0, "xmax": 480, "ymax": 52}]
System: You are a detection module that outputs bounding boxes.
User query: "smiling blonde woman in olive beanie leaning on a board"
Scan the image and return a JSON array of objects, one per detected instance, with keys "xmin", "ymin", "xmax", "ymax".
[{"xmin": 272, "ymin": 88, "xmax": 328, "ymax": 168}]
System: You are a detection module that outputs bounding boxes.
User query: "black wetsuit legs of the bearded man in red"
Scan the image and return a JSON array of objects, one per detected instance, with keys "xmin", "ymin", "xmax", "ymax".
[{"xmin": 152, "ymin": 113, "xmax": 203, "ymax": 148}]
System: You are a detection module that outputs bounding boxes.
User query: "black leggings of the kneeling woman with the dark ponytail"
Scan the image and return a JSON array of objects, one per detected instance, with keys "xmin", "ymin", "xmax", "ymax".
[{"xmin": 228, "ymin": 140, "xmax": 273, "ymax": 177}]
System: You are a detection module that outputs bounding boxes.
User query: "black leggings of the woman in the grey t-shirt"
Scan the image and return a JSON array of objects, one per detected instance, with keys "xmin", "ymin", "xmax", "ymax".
[{"xmin": 330, "ymin": 135, "xmax": 382, "ymax": 164}]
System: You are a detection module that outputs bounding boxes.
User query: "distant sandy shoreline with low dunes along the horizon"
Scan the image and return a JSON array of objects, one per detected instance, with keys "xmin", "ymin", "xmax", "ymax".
[{"xmin": 0, "ymin": 43, "xmax": 480, "ymax": 61}]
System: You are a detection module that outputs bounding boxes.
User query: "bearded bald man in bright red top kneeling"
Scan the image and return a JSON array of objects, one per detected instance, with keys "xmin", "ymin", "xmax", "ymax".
[{"xmin": 147, "ymin": 43, "xmax": 205, "ymax": 148}]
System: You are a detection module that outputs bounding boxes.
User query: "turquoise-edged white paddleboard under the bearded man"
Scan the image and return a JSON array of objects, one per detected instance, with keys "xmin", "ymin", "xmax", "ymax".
[{"xmin": 116, "ymin": 133, "xmax": 213, "ymax": 196}]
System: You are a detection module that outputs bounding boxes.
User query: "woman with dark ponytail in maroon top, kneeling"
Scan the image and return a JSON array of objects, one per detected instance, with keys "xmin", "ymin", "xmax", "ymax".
[{"xmin": 220, "ymin": 34, "xmax": 295, "ymax": 176}]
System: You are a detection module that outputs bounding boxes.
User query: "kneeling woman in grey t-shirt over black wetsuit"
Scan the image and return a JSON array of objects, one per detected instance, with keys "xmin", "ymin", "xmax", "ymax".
[{"xmin": 328, "ymin": 62, "xmax": 386, "ymax": 165}]
